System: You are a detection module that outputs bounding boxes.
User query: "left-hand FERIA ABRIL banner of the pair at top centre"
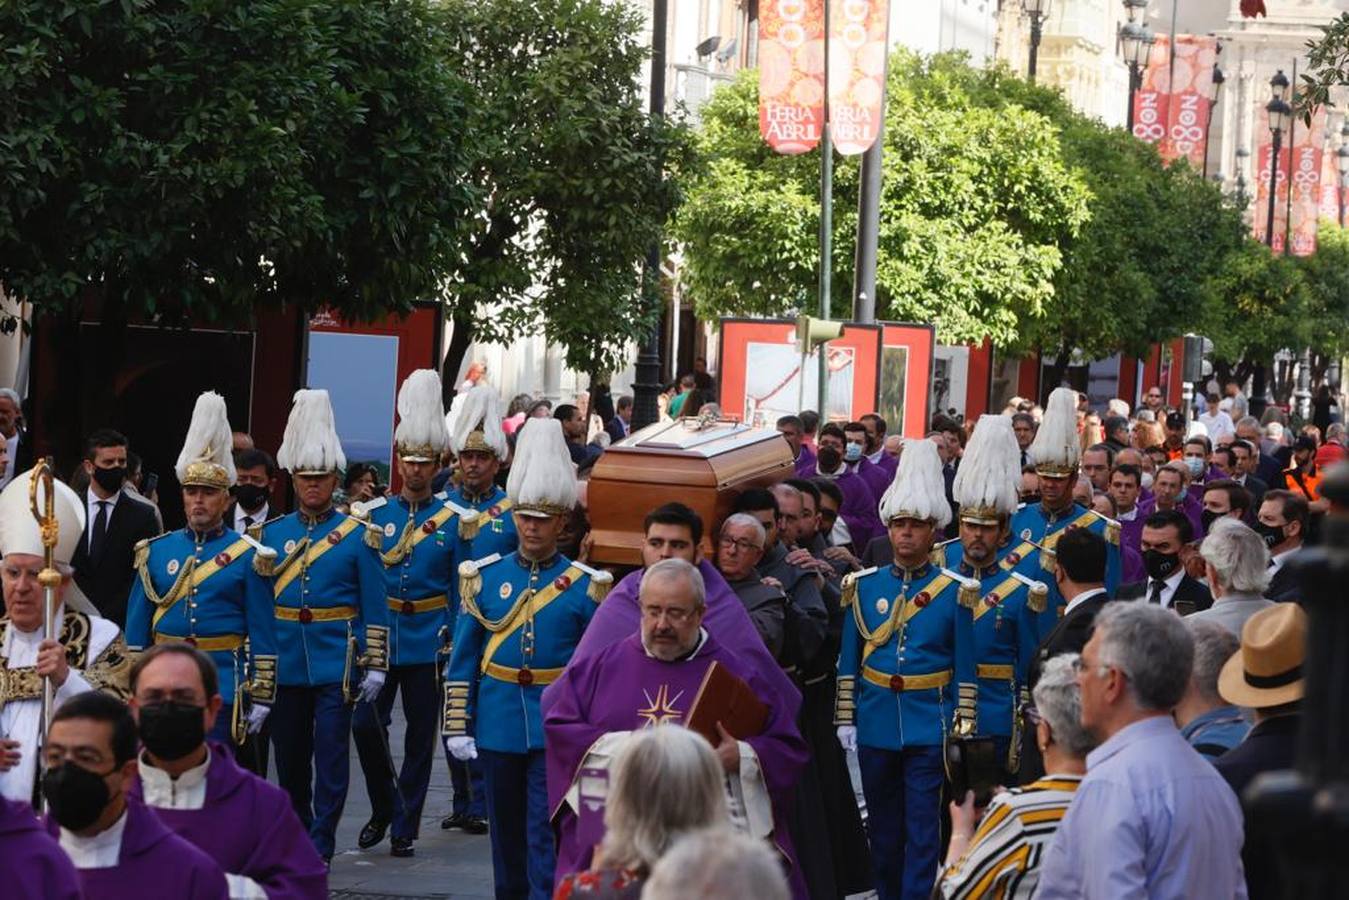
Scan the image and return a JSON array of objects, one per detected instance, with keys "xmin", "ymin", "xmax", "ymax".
[{"xmin": 758, "ymin": 0, "xmax": 824, "ymax": 155}]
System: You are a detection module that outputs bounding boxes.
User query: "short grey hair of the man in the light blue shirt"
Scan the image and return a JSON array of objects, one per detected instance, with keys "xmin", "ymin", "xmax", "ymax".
[{"xmin": 1095, "ymin": 602, "xmax": 1194, "ymax": 711}]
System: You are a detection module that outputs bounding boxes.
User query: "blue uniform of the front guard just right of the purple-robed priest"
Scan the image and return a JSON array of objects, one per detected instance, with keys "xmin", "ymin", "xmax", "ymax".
[{"xmin": 835, "ymin": 563, "xmax": 978, "ymax": 900}]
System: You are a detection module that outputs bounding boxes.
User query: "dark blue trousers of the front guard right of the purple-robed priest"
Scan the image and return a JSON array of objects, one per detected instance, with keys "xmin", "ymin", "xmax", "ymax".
[{"xmin": 857, "ymin": 746, "xmax": 946, "ymax": 900}]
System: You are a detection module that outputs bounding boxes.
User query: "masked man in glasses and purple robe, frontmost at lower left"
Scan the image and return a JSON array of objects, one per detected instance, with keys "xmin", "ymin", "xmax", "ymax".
[{"xmin": 42, "ymin": 691, "xmax": 229, "ymax": 900}]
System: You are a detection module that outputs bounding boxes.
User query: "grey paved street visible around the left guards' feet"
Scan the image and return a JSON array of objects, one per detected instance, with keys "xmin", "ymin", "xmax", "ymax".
[{"xmin": 326, "ymin": 704, "xmax": 492, "ymax": 900}]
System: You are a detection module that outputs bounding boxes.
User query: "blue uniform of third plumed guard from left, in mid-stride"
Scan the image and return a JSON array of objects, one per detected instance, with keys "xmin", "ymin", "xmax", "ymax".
[{"xmin": 352, "ymin": 494, "xmax": 465, "ymax": 841}]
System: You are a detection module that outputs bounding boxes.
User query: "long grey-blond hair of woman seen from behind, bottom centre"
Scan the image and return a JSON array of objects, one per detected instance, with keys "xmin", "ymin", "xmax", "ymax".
[{"xmin": 603, "ymin": 725, "xmax": 730, "ymax": 870}]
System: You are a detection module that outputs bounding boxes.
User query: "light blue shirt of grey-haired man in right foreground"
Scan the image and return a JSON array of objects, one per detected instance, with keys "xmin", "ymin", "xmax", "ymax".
[{"xmin": 1035, "ymin": 715, "xmax": 1246, "ymax": 900}]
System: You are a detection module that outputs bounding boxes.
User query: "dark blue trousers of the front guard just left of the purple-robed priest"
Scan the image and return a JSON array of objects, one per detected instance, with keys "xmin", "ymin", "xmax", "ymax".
[{"xmin": 478, "ymin": 749, "xmax": 557, "ymax": 900}]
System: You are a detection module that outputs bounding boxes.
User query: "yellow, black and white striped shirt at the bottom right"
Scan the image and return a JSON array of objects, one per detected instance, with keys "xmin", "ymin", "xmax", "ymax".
[{"xmin": 939, "ymin": 775, "xmax": 1082, "ymax": 900}]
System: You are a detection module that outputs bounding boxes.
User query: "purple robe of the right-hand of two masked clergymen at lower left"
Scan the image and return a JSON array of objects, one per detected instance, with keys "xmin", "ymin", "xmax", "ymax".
[{"xmin": 127, "ymin": 742, "xmax": 328, "ymax": 900}]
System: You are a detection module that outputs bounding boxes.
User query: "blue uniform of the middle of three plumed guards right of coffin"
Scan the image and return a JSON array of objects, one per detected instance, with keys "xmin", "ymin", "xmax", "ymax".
[{"xmin": 942, "ymin": 540, "xmax": 1048, "ymax": 773}]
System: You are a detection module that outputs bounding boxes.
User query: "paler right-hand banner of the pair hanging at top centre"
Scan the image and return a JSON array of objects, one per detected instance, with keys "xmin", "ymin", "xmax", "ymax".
[{"xmin": 828, "ymin": 0, "xmax": 890, "ymax": 157}]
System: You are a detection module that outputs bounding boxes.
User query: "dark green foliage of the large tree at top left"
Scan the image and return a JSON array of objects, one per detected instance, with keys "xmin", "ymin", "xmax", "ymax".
[{"xmin": 0, "ymin": 0, "xmax": 473, "ymax": 324}]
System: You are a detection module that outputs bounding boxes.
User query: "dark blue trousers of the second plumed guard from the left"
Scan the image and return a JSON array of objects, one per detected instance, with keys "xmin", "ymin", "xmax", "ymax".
[{"xmin": 267, "ymin": 684, "xmax": 351, "ymax": 860}]
